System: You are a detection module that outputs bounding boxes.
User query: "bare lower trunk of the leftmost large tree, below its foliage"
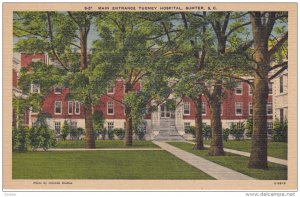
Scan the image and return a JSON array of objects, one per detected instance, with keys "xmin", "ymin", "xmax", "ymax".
[{"xmin": 84, "ymin": 101, "xmax": 96, "ymax": 148}]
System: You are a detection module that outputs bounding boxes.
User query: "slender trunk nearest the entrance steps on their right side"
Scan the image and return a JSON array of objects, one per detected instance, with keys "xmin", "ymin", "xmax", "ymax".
[{"xmin": 194, "ymin": 94, "xmax": 204, "ymax": 150}]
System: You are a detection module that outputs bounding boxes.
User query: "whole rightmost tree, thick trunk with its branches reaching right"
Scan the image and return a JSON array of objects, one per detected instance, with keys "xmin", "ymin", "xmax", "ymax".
[{"xmin": 248, "ymin": 12, "xmax": 288, "ymax": 169}]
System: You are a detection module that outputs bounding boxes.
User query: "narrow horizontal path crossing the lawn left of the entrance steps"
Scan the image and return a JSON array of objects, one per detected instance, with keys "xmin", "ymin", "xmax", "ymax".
[{"xmin": 36, "ymin": 148, "xmax": 163, "ymax": 152}]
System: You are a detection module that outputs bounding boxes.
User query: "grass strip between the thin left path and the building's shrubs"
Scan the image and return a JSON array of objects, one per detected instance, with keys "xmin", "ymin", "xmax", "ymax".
[{"xmin": 55, "ymin": 140, "xmax": 159, "ymax": 148}]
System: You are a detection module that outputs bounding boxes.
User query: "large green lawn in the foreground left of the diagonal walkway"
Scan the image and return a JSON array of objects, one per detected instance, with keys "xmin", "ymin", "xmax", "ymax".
[{"xmin": 12, "ymin": 150, "xmax": 213, "ymax": 180}]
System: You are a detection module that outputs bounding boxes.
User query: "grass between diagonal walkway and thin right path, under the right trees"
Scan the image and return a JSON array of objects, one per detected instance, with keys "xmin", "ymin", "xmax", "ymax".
[{"xmin": 169, "ymin": 142, "xmax": 287, "ymax": 180}]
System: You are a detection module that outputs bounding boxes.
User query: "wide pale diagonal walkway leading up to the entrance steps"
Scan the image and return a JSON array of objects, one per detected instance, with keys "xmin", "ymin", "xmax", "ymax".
[{"xmin": 153, "ymin": 141, "xmax": 255, "ymax": 180}]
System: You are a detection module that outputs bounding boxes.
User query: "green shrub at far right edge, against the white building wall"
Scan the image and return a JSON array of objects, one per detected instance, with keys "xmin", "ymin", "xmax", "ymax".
[{"xmin": 272, "ymin": 118, "xmax": 288, "ymax": 142}]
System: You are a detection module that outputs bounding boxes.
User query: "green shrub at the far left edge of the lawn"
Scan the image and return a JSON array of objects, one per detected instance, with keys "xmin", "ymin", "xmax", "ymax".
[{"xmin": 13, "ymin": 126, "xmax": 29, "ymax": 152}]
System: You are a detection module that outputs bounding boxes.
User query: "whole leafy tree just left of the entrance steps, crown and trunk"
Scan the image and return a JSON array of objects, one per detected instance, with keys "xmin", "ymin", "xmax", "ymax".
[{"xmin": 95, "ymin": 12, "xmax": 177, "ymax": 146}]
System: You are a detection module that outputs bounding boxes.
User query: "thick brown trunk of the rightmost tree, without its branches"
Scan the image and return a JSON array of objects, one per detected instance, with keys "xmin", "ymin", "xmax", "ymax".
[{"xmin": 248, "ymin": 12, "xmax": 270, "ymax": 169}]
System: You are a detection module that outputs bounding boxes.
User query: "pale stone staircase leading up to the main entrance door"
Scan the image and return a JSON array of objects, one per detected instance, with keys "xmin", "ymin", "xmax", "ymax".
[{"xmin": 154, "ymin": 118, "xmax": 184, "ymax": 141}]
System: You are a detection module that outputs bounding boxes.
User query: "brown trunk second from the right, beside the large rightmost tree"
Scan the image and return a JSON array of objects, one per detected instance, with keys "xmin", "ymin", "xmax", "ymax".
[{"xmin": 208, "ymin": 84, "xmax": 224, "ymax": 156}]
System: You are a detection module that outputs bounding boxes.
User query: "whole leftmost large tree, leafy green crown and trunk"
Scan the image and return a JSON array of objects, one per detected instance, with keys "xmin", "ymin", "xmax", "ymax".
[{"xmin": 14, "ymin": 12, "xmax": 115, "ymax": 148}]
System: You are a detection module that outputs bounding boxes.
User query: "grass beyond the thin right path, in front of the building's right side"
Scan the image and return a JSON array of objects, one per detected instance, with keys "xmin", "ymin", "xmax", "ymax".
[{"xmin": 200, "ymin": 140, "xmax": 287, "ymax": 159}]
